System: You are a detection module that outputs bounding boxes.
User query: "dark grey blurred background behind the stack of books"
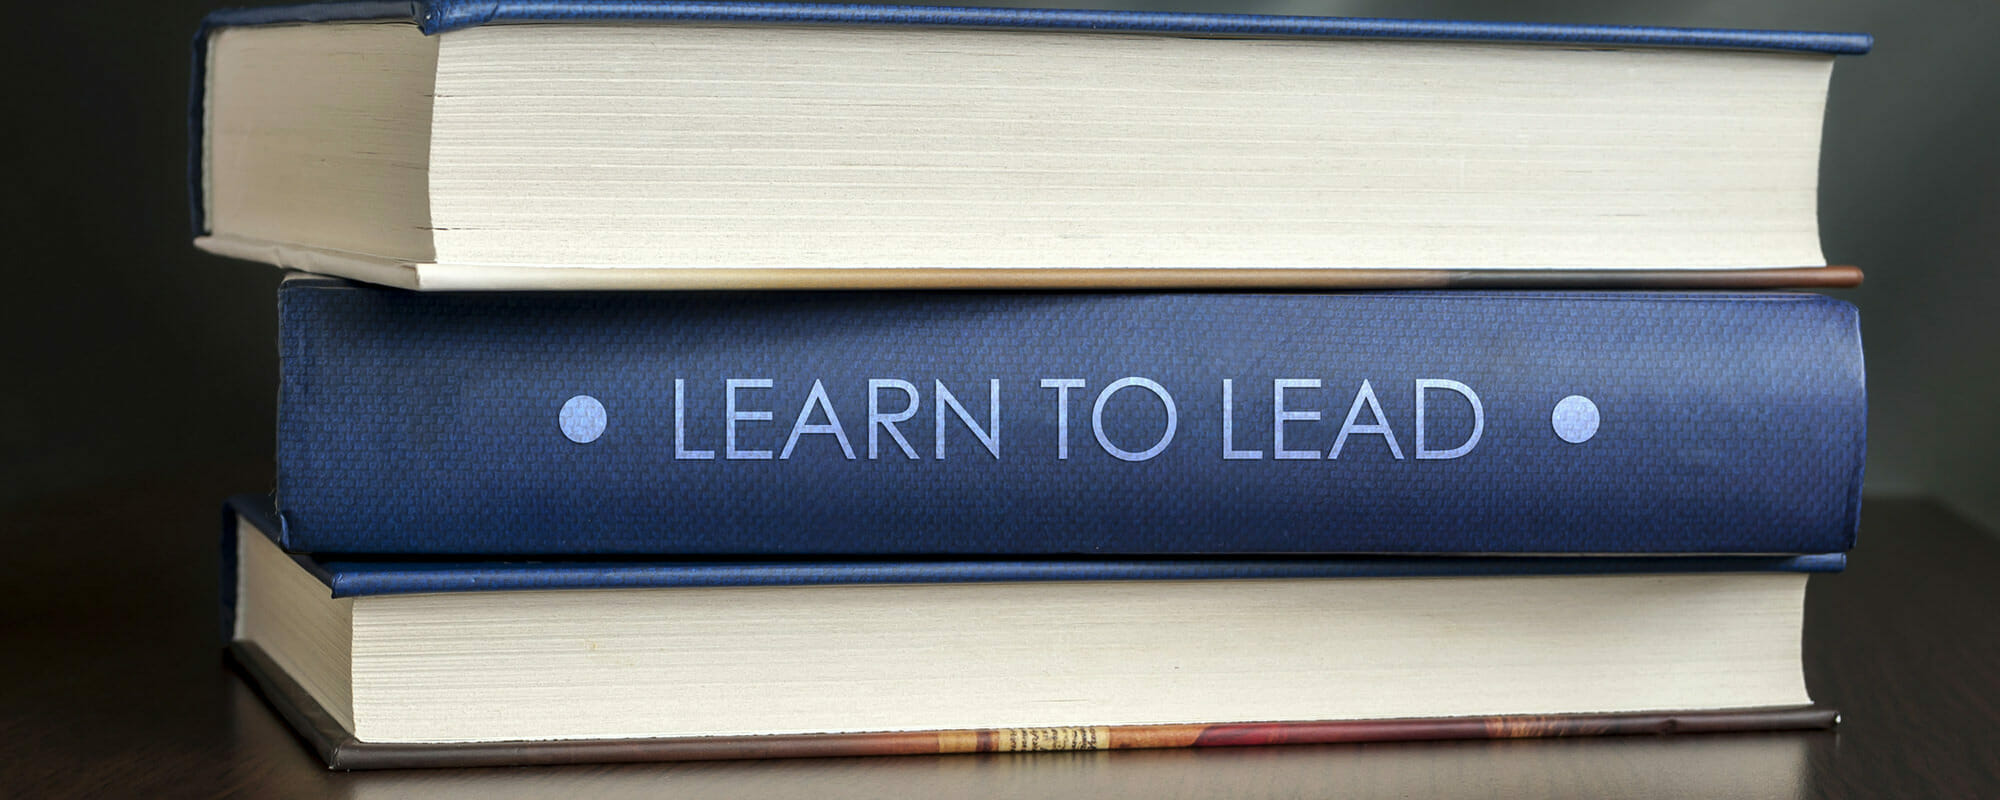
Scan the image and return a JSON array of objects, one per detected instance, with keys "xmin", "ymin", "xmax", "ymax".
[{"xmin": 0, "ymin": 0, "xmax": 2000, "ymax": 546}]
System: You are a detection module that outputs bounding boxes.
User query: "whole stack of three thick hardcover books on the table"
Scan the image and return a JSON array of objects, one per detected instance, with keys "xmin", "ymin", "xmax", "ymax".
[{"xmin": 192, "ymin": 0, "xmax": 1868, "ymax": 768}]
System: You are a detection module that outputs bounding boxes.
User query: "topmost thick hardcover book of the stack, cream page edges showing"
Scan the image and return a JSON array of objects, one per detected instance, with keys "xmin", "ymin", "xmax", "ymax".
[{"xmin": 190, "ymin": 0, "xmax": 1870, "ymax": 290}]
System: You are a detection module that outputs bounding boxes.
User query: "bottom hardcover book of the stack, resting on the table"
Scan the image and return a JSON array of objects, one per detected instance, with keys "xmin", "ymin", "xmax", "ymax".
[{"xmin": 224, "ymin": 498, "xmax": 1844, "ymax": 768}]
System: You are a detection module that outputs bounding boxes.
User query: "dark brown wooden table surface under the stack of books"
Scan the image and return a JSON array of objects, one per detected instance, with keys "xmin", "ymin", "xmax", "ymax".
[{"xmin": 0, "ymin": 476, "xmax": 2000, "ymax": 800}]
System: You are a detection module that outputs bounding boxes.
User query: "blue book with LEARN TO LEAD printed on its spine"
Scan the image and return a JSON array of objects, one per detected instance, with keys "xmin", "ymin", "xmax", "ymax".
[{"xmin": 276, "ymin": 278, "xmax": 1866, "ymax": 556}]
